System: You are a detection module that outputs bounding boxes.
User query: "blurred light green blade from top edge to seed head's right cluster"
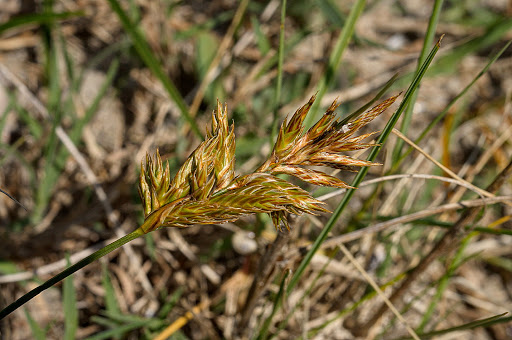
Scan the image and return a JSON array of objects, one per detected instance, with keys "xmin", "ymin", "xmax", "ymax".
[{"xmin": 304, "ymin": 0, "xmax": 366, "ymax": 127}]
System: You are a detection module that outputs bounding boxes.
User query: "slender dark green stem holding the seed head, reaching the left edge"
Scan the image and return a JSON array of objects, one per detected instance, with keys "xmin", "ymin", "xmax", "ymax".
[{"xmin": 0, "ymin": 228, "xmax": 144, "ymax": 320}]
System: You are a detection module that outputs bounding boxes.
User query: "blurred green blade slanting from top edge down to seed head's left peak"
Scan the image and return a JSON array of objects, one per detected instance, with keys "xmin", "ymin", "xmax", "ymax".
[{"xmin": 108, "ymin": 0, "xmax": 203, "ymax": 139}]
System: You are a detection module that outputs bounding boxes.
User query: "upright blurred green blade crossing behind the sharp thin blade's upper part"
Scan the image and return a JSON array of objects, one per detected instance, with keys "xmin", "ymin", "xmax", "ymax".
[{"xmin": 392, "ymin": 0, "xmax": 443, "ymax": 163}]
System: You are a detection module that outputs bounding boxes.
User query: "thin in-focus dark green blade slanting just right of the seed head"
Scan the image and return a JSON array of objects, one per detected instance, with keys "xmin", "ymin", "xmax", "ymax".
[{"xmin": 287, "ymin": 40, "xmax": 441, "ymax": 294}]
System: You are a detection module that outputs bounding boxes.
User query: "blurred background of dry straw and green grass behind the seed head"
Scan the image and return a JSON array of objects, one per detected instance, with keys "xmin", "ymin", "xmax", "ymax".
[{"xmin": 0, "ymin": 0, "xmax": 512, "ymax": 339}]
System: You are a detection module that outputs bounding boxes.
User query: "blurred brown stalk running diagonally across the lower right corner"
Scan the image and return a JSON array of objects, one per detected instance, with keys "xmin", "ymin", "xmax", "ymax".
[{"xmin": 353, "ymin": 159, "xmax": 512, "ymax": 336}]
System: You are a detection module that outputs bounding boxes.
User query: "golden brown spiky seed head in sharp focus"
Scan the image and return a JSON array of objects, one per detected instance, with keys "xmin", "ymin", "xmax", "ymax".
[{"xmin": 139, "ymin": 96, "xmax": 397, "ymax": 233}]
